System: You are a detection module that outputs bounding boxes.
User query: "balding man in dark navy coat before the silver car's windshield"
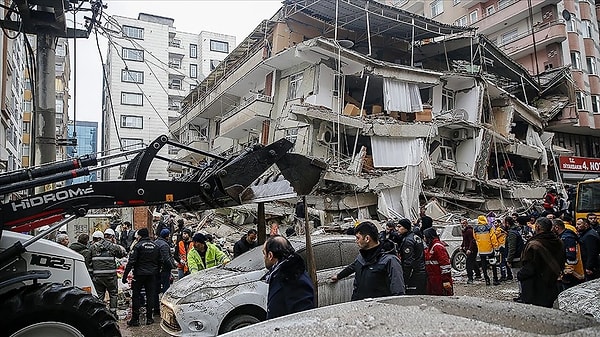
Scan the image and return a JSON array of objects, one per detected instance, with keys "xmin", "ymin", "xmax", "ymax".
[{"xmin": 263, "ymin": 235, "xmax": 315, "ymax": 319}]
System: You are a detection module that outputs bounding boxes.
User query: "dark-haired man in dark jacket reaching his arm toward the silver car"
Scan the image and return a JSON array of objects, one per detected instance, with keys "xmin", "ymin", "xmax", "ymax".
[{"xmin": 331, "ymin": 221, "xmax": 405, "ymax": 301}]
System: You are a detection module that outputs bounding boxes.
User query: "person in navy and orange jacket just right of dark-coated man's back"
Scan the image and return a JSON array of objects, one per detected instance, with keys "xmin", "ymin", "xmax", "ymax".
[{"xmin": 552, "ymin": 219, "xmax": 585, "ymax": 291}]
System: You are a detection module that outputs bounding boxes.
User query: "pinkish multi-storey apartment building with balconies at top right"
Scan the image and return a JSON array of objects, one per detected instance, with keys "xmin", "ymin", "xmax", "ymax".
[{"xmin": 394, "ymin": 0, "xmax": 600, "ymax": 182}]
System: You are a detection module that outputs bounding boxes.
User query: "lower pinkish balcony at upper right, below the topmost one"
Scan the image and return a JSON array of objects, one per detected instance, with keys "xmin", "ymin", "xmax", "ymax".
[{"xmin": 499, "ymin": 21, "xmax": 567, "ymax": 60}]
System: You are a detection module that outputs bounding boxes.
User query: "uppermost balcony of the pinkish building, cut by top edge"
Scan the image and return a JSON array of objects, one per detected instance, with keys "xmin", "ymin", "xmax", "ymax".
[{"xmin": 471, "ymin": 0, "xmax": 560, "ymax": 36}]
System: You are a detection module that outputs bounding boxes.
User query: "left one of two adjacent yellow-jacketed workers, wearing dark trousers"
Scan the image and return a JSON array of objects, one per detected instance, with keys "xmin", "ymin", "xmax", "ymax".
[{"xmin": 473, "ymin": 215, "xmax": 500, "ymax": 286}]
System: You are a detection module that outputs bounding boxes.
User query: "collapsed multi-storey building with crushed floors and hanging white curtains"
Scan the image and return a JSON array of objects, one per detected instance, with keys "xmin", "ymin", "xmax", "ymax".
[{"xmin": 170, "ymin": 0, "xmax": 568, "ymax": 223}]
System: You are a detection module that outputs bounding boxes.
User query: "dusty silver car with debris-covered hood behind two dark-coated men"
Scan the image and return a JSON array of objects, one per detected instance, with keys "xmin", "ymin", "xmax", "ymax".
[{"xmin": 161, "ymin": 235, "xmax": 358, "ymax": 336}]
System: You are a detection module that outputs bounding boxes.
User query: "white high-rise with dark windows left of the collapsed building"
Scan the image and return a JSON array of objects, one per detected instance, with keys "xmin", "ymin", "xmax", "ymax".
[{"xmin": 102, "ymin": 13, "xmax": 235, "ymax": 179}]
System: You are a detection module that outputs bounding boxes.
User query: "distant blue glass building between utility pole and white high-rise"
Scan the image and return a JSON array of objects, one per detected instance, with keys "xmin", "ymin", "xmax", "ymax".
[{"xmin": 66, "ymin": 121, "xmax": 98, "ymax": 185}]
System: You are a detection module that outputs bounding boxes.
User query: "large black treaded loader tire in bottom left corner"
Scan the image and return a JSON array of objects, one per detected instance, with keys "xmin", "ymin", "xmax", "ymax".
[{"xmin": 0, "ymin": 283, "xmax": 121, "ymax": 337}]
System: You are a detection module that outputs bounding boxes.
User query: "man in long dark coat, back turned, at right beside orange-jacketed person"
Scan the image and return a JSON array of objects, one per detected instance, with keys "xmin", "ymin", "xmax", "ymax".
[{"xmin": 517, "ymin": 217, "xmax": 566, "ymax": 308}]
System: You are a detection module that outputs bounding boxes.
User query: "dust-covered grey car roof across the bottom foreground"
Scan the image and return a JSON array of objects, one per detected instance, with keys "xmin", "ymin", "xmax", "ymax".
[{"xmin": 223, "ymin": 296, "xmax": 600, "ymax": 337}]
